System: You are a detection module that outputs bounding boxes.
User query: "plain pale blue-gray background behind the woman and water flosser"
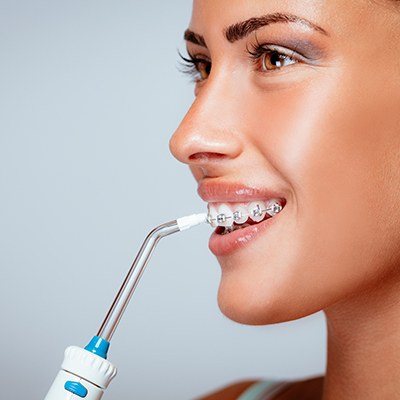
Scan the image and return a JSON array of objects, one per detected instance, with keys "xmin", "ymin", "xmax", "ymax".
[{"xmin": 0, "ymin": 0, "xmax": 326, "ymax": 400}]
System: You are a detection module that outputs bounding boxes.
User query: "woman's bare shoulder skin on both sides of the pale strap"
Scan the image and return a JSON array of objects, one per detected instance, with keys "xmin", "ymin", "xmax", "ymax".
[{"xmin": 195, "ymin": 376, "xmax": 324, "ymax": 400}]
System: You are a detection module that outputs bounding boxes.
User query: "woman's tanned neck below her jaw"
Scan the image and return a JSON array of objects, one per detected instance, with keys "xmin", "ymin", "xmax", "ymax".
[{"xmin": 323, "ymin": 281, "xmax": 400, "ymax": 400}]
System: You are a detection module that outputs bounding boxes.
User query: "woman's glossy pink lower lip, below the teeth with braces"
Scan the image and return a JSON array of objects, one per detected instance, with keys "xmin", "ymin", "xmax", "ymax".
[{"xmin": 208, "ymin": 209, "xmax": 284, "ymax": 256}]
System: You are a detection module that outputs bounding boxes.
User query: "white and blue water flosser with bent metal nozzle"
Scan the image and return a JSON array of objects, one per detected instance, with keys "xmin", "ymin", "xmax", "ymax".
[{"xmin": 45, "ymin": 214, "xmax": 207, "ymax": 400}]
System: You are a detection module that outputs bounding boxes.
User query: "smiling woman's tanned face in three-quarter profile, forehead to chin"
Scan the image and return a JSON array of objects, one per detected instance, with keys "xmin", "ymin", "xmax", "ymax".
[{"xmin": 171, "ymin": 0, "xmax": 400, "ymax": 324}]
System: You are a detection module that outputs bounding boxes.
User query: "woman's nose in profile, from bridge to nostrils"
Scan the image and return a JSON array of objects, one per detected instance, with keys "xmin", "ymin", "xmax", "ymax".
[{"xmin": 170, "ymin": 78, "xmax": 243, "ymax": 174}]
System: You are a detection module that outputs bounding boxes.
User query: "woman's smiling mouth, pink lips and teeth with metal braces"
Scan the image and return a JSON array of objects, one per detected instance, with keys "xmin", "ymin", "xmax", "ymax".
[{"xmin": 198, "ymin": 181, "xmax": 286, "ymax": 256}]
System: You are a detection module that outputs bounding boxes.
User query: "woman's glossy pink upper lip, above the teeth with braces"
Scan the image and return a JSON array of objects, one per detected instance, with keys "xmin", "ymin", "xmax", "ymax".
[{"xmin": 197, "ymin": 180, "xmax": 283, "ymax": 203}]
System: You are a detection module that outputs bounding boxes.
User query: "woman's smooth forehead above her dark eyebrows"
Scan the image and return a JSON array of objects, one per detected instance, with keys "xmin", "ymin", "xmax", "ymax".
[{"xmin": 189, "ymin": 0, "xmax": 399, "ymax": 43}]
